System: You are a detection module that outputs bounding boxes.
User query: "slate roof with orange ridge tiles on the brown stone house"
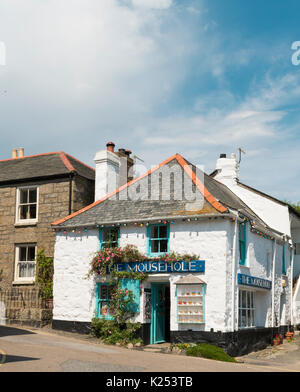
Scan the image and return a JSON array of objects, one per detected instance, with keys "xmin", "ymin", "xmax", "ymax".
[{"xmin": 0, "ymin": 151, "xmax": 95, "ymax": 185}]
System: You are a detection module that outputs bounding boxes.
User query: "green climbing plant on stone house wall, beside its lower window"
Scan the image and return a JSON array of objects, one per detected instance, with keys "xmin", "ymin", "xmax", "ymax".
[{"xmin": 35, "ymin": 250, "xmax": 54, "ymax": 299}]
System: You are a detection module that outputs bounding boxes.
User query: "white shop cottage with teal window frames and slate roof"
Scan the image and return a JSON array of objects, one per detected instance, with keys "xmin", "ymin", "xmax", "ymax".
[{"xmin": 53, "ymin": 144, "xmax": 293, "ymax": 355}]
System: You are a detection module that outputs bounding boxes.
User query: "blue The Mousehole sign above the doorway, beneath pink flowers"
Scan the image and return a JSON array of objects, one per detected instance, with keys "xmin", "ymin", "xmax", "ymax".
[{"xmin": 109, "ymin": 260, "xmax": 205, "ymax": 274}]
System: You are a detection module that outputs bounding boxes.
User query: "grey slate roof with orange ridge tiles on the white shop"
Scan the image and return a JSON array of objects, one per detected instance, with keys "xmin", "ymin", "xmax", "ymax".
[{"xmin": 52, "ymin": 154, "xmax": 274, "ymax": 233}]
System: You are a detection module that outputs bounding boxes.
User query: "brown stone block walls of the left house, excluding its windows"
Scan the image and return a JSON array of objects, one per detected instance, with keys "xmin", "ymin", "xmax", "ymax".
[{"xmin": 0, "ymin": 176, "xmax": 94, "ymax": 324}]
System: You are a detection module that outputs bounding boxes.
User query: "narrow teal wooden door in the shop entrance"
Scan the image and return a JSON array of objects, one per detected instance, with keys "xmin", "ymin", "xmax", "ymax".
[{"xmin": 150, "ymin": 284, "xmax": 166, "ymax": 344}]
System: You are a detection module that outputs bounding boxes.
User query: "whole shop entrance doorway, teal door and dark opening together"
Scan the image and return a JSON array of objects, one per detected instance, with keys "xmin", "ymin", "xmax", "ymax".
[{"xmin": 150, "ymin": 283, "xmax": 170, "ymax": 344}]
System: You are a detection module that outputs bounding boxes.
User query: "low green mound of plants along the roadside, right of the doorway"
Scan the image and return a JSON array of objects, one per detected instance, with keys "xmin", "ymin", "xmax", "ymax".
[{"xmin": 177, "ymin": 343, "xmax": 236, "ymax": 362}]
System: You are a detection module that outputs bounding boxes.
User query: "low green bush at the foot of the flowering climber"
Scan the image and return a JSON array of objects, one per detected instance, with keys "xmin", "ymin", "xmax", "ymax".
[{"xmin": 91, "ymin": 318, "xmax": 142, "ymax": 346}]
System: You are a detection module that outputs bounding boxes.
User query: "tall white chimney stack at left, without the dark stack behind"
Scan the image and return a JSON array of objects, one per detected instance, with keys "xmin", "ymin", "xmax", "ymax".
[{"xmin": 94, "ymin": 142, "xmax": 120, "ymax": 201}]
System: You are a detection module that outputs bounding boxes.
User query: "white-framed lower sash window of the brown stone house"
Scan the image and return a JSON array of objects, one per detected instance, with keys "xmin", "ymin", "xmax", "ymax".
[{"xmin": 15, "ymin": 244, "xmax": 36, "ymax": 282}]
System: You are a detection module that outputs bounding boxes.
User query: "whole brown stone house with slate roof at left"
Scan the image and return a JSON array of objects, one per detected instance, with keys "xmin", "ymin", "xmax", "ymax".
[{"xmin": 0, "ymin": 149, "xmax": 95, "ymax": 325}]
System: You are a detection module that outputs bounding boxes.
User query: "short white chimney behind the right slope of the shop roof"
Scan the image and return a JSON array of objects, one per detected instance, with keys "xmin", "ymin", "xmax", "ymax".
[{"xmin": 214, "ymin": 154, "xmax": 239, "ymax": 185}]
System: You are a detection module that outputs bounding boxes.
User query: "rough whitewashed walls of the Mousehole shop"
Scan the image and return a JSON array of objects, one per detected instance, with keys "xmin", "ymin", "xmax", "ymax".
[{"xmin": 53, "ymin": 219, "xmax": 290, "ymax": 331}]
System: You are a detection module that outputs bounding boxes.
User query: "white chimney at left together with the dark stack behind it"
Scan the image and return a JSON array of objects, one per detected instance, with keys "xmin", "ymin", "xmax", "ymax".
[{"xmin": 94, "ymin": 142, "xmax": 134, "ymax": 201}]
